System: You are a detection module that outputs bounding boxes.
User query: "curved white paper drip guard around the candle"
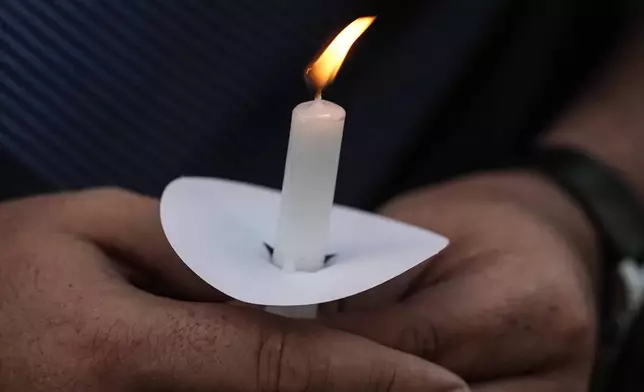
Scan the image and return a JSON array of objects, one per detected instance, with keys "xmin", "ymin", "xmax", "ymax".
[{"xmin": 161, "ymin": 177, "xmax": 448, "ymax": 313}]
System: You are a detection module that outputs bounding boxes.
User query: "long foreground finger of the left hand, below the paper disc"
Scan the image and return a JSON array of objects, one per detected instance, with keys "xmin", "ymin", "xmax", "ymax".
[{"xmin": 124, "ymin": 300, "xmax": 466, "ymax": 392}]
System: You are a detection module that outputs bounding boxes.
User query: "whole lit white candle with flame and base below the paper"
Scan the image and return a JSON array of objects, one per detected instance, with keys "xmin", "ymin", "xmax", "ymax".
[{"xmin": 267, "ymin": 17, "xmax": 375, "ymax": 318}]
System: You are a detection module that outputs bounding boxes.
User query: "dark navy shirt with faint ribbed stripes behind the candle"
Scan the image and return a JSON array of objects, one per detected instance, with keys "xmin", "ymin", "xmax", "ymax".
[{"xmin": 0, "ymin": 0, "xmax": 627, "ymax": 208}]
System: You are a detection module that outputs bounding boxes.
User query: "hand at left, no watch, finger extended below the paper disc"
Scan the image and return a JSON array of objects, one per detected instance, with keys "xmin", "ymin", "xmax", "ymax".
[{"xmin": 0, "ymin": 190, "xmax": 462, "ymax": 392}]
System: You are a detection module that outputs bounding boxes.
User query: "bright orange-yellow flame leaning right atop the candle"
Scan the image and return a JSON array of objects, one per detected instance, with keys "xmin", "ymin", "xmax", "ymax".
[{"xmin": 306, "ymin": 16, "xmax": 376, "ymax": 98}]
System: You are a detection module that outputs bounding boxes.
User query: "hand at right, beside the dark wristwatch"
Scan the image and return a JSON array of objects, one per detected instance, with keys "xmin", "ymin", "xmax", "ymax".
[{"xmin": 325, "ymin": 173, "xmax": 597, "ymax": 392}]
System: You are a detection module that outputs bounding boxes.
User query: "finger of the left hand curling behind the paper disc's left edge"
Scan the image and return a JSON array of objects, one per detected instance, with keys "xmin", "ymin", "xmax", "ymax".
[{"xmin": 58, "ymin": 189, "xmax": 227, "ymax": 301}]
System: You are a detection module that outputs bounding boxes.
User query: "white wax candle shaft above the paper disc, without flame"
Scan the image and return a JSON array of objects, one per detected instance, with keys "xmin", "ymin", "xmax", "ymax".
[{"xmin": 273, "ymin": 99, "xmax": 346, "ymax": 272}]
